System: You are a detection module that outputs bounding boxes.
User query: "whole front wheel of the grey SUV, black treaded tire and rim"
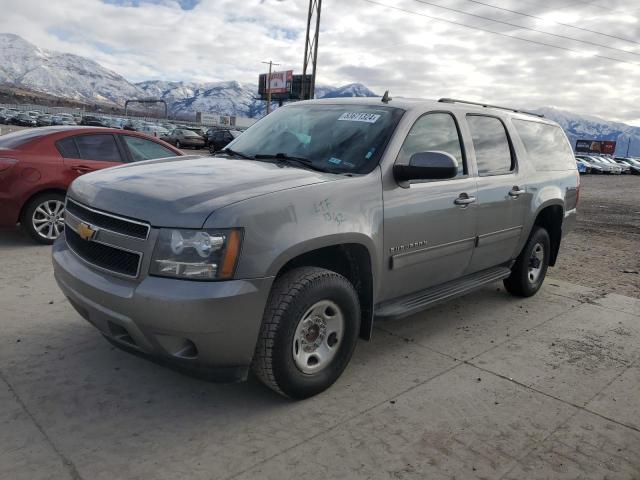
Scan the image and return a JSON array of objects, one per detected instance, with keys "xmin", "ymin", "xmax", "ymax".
[{"xmin": 252, "ymin": 267, "xmax": 360, "ymax": 399}]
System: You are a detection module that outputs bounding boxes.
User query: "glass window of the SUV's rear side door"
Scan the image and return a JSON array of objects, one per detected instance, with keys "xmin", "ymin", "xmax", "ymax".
[{"xmin": 467, "ymin": 115, "xmax": 515, "ymax": 177}]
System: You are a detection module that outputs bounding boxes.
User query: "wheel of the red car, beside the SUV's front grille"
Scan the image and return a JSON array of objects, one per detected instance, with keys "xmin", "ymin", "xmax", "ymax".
[{"xmin": 20, "ymin": 192, "xmax": 64, "ymax": 245}]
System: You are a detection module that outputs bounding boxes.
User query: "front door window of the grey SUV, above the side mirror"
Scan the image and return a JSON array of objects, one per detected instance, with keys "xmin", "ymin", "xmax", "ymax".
[{"xmin": 396, "ymin": 113, "xmax": 467, "ymax": 176}]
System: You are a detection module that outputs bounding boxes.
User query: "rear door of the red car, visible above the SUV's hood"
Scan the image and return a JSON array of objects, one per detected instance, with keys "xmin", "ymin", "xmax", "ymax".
[{"xmin": 56, "ymin": 133, "xmax": 124, "ymax": 180}]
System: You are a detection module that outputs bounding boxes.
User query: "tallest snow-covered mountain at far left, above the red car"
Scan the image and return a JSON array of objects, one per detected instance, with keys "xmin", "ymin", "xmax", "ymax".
[{"xmin": 0, "ymin": 33, "xmax": 140, "ymax": 105}]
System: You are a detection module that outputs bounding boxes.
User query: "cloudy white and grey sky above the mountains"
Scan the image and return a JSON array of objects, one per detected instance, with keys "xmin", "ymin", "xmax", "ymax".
[{"xmin": 0, "ymin": 0, "xmax": 640, "ymax": 125}]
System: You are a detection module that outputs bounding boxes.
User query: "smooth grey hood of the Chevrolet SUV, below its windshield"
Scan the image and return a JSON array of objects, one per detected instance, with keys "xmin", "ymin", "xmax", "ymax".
[{"xmin": 69, "ymin": 156, "xmax": 342, "ymax": 228}]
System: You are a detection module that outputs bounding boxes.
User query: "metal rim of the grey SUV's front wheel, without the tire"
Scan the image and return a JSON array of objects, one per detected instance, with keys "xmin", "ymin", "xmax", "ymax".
[{"xmin": 292, "ymin": 300, "xmax": 344, "ymax": 374}]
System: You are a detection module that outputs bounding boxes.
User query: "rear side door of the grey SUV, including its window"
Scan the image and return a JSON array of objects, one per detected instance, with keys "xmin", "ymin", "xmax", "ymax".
[{"xmin": 466, "ymin": 114, "xmax": 531, "ymax": 273}]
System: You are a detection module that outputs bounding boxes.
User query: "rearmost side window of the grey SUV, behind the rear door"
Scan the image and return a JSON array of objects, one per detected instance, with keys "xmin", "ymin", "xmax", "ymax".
[{"xmin": 513, "ymin": 119, "xmax": 576, "ymax": 171}]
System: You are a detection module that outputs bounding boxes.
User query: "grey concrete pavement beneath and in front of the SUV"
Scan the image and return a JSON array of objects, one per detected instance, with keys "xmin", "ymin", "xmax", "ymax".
[{"xmin": 0, "ymin": 231, "xmax": 640, "ymax": 480}]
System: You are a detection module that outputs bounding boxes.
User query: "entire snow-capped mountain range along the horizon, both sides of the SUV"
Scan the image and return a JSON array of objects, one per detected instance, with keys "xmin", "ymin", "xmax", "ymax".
[{"xmin": 0, "ymin": 33, "xmax": 640, "ymax": 155}]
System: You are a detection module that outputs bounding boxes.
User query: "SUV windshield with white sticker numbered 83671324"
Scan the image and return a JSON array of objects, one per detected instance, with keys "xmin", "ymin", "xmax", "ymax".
[{"xmin": 228, "ymin": 104, "xmax": 404, "ymax": 173}]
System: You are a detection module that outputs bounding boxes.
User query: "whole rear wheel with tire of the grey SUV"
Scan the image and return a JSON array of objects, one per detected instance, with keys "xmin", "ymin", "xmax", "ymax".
[{"xmin": 503, "ymin": 226, "xmax": 551, "ymax": 297}]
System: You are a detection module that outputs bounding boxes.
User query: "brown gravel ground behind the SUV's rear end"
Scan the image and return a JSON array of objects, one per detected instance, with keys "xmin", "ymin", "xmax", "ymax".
[{"xmin": 549, "ymin": 175, "xmax": 640, "ymax": 298}]
